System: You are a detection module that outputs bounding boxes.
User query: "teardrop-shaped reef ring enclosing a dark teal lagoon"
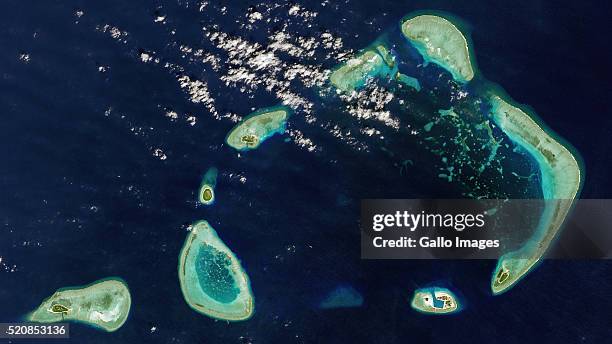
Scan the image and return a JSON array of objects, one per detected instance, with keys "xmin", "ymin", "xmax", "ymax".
[{"xmin": 178, "ymin": 221, "xmax": 255, "ymax": 321}]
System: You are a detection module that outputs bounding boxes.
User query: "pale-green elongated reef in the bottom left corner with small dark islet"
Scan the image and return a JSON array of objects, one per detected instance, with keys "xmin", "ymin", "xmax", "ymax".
[{"xmin": 26, "ymin": 278, "xmax": 132, "ymax": 332}]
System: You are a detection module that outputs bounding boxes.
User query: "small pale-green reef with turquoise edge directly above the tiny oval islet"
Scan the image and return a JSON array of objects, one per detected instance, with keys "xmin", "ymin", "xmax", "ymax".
[{"xmin": 225, "ymin": 106, "xmax": 289, "ymax": 151}]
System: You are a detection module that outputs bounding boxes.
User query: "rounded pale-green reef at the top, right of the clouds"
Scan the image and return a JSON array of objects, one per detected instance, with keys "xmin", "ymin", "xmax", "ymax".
[{"xmin": 401, "ymin": 15, "xmax": 474, "ymax": 83}]
